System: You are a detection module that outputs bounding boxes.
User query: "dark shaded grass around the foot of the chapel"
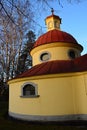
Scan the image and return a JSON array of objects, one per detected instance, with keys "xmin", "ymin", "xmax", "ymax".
[{"xmin": 0, "ymin": 101, "xmax": 87, "ymax": 130}]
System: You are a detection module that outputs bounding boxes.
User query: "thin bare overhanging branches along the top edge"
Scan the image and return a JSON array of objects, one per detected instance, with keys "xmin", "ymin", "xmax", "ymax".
[{"xmin": 0, "ymin": 0, "xmax": 82, "ymax": 24}]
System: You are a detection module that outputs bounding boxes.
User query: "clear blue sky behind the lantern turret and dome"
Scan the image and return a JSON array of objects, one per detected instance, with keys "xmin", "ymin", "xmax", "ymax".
[{"xmin": 33, "ymin": 0, "xmax": 87, "ymax": 55}]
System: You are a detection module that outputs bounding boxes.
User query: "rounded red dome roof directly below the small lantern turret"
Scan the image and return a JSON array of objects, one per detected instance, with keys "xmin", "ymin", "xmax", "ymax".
[{"xmin": 34, "ymin": 29, "xmax": 78, "ymax": 47}]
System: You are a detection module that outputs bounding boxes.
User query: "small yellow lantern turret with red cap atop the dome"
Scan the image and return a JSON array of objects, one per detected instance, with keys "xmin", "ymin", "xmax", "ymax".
[{"xmin": 45, "ymin": 9, "xmax": 61, "ymax": 31}]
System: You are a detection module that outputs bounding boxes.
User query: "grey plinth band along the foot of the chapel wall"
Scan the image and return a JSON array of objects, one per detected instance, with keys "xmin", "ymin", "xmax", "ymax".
[{"xmin": 9, "ymin": 112, "xmax": 87, "ymax": 122}]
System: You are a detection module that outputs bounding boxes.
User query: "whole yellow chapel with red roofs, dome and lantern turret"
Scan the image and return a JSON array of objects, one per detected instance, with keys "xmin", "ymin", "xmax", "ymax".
[{"xmin": 8, "ymin": 11, "xmax": 87, "ymax": 122}]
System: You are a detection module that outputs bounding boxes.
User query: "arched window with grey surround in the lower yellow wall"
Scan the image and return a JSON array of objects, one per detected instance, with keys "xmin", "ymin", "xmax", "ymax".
[{"xmin": 21, "ymin": 82, "xmax": 38, "ymax": 97}]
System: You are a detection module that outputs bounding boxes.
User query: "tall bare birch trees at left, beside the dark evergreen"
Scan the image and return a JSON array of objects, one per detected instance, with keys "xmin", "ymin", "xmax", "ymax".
[{"xmin": 0, "ymin": 0, "xmax": 32, "ymax": 80}]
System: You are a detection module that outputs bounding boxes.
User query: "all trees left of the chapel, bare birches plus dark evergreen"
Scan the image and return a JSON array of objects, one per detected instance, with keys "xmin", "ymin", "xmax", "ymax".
[{"xmin": 0, "ymin": 0, "xmax": 84, "ymax": 93}]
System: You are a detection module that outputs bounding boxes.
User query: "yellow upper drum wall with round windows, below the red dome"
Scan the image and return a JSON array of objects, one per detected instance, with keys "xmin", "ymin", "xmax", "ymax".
[{"xmin": 31, "ymin": 43, "xmax": 81, "ymax": 66}]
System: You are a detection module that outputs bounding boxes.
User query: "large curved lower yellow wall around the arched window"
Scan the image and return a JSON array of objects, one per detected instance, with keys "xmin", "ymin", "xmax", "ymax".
[{"xmin": 8, "ymin": 72, "xmax": 87, "ymax": 115}]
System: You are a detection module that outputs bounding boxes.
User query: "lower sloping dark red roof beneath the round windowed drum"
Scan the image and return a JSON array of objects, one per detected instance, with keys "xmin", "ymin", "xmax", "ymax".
[{"xmin": 16, "ymin": 54, "xmax": 87, "ymax": 78}]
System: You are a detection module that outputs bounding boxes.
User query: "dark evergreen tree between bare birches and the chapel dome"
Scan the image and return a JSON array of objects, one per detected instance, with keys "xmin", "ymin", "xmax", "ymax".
[{"xmin": 16, "ymin": 30, "xmax": 36, "ymax": 74}]
